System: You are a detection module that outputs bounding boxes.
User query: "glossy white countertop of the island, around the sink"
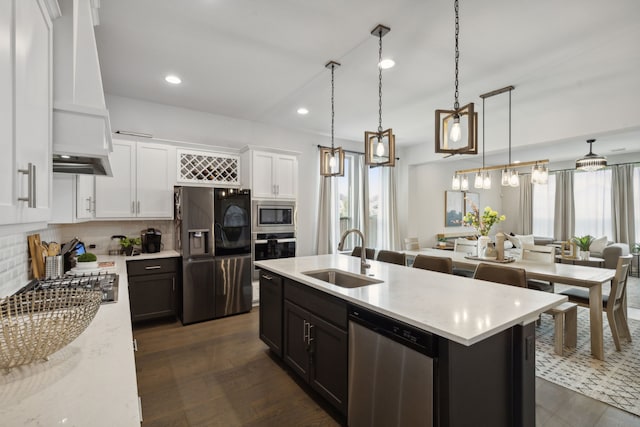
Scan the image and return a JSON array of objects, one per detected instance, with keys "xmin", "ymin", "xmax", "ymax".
[{"xmin": 255, "ymin": 255, "xmax": 567, "ymax": 345}]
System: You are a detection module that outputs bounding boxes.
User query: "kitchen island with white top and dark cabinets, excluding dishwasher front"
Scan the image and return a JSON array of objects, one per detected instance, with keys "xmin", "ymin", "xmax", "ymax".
[{"xmin": 256, "ymin": 255, "xmax": 566, "ymax": 425}]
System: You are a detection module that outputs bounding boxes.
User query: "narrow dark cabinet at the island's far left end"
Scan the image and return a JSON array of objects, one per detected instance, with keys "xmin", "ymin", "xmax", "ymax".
[{"xmin": 260, "ymin": 271, "xmax": 283, "ymax": 357}]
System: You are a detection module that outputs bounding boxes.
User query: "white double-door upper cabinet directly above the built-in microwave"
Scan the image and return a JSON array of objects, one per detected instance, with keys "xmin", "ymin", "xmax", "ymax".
[{"xmin": 242, "ymin": 150, "xmax": 298, "ymax": 200}]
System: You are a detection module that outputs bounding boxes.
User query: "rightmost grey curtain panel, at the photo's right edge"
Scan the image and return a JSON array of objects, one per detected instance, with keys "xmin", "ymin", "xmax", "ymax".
[{"xmin": 611, "ymin": 165, "xmax": 636, "ymax": 244}]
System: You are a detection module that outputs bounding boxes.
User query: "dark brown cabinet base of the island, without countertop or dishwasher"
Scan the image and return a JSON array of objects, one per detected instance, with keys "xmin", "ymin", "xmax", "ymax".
[{"xmin": 260, "ymin": 270, "xmax": 536, "ymax": 427}]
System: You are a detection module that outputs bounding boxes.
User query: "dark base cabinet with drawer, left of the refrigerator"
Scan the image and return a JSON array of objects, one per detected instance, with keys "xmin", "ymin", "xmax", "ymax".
[{"xmin": 127, "ymin": 258, "xmax": 180, "ymax": 322}]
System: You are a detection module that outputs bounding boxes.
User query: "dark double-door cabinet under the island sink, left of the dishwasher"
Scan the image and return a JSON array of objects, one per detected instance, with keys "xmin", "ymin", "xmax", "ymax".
[{"xmin": 283, "ymin": 280, "xmax": 349, "ymax": 415}]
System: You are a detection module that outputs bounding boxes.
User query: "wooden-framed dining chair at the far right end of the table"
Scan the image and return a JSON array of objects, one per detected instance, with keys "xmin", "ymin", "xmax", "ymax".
[{"xmin": 560, "ymin": 255, "xmax": 633, "ymax": 351}]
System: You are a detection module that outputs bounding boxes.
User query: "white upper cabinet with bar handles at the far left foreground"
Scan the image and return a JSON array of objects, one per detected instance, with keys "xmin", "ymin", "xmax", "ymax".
[{"xmin": 0, "ymin": 0, "xmax": 52, "ymax": 225}]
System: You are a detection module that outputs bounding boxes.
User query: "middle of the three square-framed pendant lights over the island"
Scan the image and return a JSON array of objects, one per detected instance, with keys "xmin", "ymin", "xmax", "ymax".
[{"xmin": 364, "ymin": 25, "xmax": 396, "ymax": 166}]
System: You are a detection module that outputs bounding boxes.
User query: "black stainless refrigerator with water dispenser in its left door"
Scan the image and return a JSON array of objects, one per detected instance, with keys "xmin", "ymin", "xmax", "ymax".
[{"xmin": 174, "ymin": 187, "xmax": 252, "ymax": 325}]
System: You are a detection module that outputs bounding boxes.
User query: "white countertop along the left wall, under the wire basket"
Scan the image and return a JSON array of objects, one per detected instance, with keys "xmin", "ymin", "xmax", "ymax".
[{"xmin": 0, "ymin": 254, "xmax": 141, "ymax": 427}]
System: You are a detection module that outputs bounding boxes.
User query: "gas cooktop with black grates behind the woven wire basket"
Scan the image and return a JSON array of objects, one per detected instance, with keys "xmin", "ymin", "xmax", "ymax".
[{"xmin": 16, "ymin": 272, "xmax": 118, "ymax": 304}]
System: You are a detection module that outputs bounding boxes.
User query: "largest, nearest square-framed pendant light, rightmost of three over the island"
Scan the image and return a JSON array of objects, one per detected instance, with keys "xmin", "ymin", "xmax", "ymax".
[{"xmin": 435, "ymin": 0, "xmax": 478, "ymax": 154}]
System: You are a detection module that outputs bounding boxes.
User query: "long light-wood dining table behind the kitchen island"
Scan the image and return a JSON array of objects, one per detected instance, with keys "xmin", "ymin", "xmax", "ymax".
[{"xmin": 404, "ymin": 248, "xmax": 616, "ymax": 360}]
